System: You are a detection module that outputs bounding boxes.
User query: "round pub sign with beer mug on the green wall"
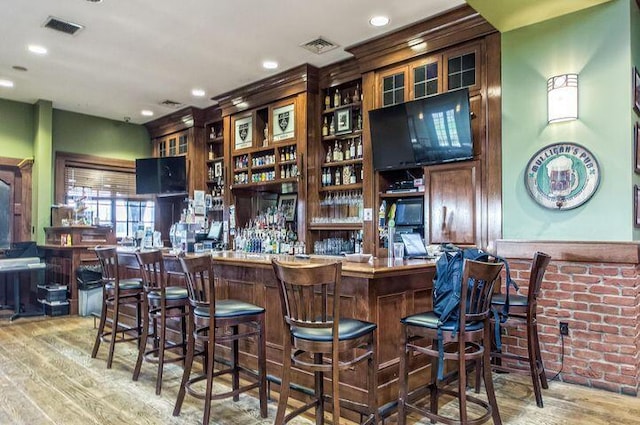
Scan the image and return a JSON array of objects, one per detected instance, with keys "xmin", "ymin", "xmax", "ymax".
[{"xmin": 524, "ymin": 143, "xmax": 600, "ymax": 210}]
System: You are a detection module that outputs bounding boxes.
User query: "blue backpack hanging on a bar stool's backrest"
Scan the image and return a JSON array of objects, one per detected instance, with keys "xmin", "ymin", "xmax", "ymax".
[{"xmin": 433, "ymin": 248, "xmax": 518, "ymax": 380}]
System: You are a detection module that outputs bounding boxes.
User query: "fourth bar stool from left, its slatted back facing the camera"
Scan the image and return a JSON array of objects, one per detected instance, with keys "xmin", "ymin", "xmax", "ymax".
[{"xmin": 272, "ymin": 259, "xmax": 379, "ymax": 425}]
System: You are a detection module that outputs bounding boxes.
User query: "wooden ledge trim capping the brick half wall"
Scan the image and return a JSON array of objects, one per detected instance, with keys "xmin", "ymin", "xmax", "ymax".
[{"xmin": 496, "ymin": 239, "xmax": 640, "ymax": 264}]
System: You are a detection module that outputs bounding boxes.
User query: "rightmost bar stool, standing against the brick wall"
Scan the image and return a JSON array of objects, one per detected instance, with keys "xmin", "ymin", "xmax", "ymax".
[{"xmin": 491, "ymin": 252, "xmax": 551, "ymax": 407}]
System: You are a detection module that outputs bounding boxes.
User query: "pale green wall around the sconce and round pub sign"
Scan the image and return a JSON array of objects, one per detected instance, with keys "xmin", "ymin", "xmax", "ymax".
[{"xmin": 502, "ymin": 0, "xmax": 637, "ymax": 241}]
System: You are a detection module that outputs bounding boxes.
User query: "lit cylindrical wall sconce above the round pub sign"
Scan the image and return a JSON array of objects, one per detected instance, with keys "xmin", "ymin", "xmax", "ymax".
[{"xmin": 547, "ymin": 74, "xmax": 578, "ymax": 123}]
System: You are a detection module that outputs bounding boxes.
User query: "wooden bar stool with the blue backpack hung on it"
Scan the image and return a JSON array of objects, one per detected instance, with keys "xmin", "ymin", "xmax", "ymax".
[{"xmin": 398, "ymin": 260, "xmax": 502, "ymax": 425}]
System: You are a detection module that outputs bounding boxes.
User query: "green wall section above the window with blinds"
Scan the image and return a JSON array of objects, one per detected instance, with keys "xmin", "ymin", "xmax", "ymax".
[{"xmin": 53, "ymin": 109, "xmax": 151, "ymax": 160}]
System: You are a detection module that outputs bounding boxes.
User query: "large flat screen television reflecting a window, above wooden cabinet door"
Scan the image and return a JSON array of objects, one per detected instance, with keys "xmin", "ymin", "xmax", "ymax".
[{"xmin": 369, "ymin": 88, "xmax": 473, "ymax": 170}]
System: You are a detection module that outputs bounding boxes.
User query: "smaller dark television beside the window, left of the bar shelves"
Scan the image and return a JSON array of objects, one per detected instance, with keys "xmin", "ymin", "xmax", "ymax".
[{"xmin": 136, "ymin": 156, "xmax": 187, "ymax": 195}]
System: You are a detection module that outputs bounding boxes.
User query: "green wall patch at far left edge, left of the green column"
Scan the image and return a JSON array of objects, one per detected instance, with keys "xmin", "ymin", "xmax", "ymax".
[{"xmin": 0, "ymin": 99, "xmax": 35, "ymax": 159}]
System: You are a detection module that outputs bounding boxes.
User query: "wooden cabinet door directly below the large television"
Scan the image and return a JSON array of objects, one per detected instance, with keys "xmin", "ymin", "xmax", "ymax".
[{"xmin": 424, "ymin": 161, "xmax": 481, "ymax": 245}]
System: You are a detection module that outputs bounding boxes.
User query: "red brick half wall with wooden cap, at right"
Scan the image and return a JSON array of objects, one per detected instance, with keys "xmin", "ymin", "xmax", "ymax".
[{"xmin": 496, "ymin": 240, "xmax": 640, "ymax": 395}]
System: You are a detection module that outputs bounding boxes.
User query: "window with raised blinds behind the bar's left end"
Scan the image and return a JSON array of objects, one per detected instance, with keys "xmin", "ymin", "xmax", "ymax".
[{"xmin": 56, "ymin": 154, "xmax": 155, "ymax": 239}]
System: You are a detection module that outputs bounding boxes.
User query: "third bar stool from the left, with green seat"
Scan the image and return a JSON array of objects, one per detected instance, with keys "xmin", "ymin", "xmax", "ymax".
[{"xmin": 173, "ymin": 255, "xmax": 267, "ymax": 424}]
